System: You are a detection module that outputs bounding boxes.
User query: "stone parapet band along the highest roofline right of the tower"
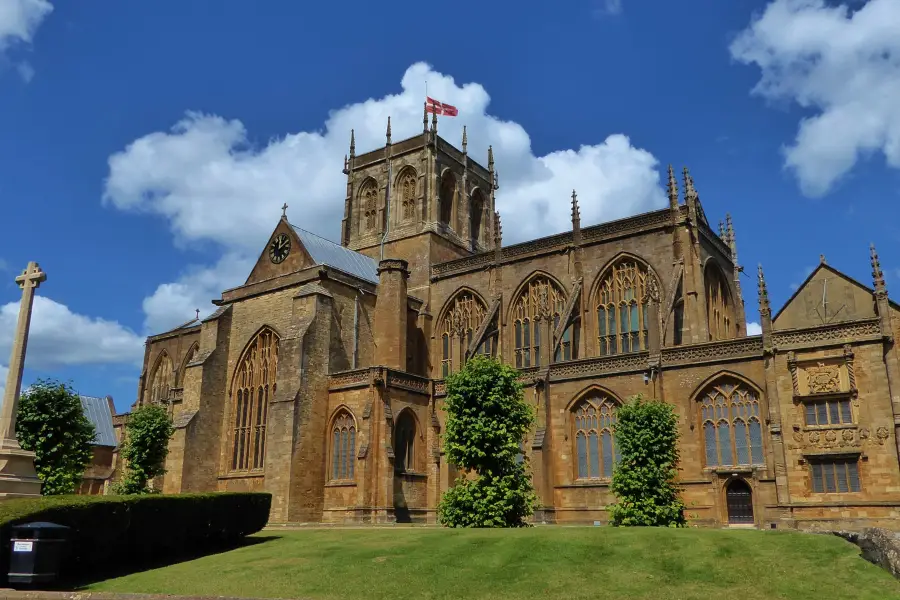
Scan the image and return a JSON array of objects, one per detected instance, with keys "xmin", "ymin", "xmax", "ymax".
[{"xmin": 431, "ymin": 208, "xmax": 672, "ymax": 281}]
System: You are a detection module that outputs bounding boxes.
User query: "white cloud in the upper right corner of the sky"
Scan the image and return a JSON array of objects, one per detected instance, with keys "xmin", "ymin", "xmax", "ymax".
[{"xmin": 730, "ymin": 0, "xmax": 900, "ymax": 196}]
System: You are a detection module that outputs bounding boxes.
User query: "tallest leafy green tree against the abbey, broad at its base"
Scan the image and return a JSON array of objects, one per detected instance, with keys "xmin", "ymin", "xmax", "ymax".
[{"xmin": 438, "ymin": 356, "xmax": 536, "ymax": 527}]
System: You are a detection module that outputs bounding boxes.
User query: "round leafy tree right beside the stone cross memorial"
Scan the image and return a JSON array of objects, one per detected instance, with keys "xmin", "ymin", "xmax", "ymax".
[{"xmin": 16, "ymin": 379, "xmax": 97, "ymax": 496}]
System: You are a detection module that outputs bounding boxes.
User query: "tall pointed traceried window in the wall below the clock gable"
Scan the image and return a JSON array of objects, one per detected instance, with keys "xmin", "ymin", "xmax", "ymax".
[{"xmin": 230, "ymin": 329, "xmax": 278, "ymax": 471}]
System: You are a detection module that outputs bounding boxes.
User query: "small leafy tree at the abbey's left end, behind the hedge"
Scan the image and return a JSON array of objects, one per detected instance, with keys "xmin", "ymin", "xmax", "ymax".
[{"xmin": 115, "ymin": 404, "xmax": 175, "ymax": 494}]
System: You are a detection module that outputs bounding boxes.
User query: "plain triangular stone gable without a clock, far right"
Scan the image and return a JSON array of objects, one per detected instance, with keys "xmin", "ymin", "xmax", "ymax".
[{"xmin": 772, "ymin": 263, "xmax": 877, "ymax": 329}]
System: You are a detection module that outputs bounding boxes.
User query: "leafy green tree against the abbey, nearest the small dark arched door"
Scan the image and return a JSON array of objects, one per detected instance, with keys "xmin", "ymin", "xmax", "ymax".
[{"xmin": 609, "ymin": 394, "xmax": 686, "ymax": 527}]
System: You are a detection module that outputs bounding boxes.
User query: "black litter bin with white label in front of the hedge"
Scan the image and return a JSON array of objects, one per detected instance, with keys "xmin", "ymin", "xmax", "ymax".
[{"xmin": 8, "ymin": 523, "xmax": 69, "ymax": 585}]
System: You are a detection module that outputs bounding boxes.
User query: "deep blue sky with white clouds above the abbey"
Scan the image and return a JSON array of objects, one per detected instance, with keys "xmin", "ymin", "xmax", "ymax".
[{"xmin": 0, "ymin": 0, "xmax": 900, "ymax": 409}]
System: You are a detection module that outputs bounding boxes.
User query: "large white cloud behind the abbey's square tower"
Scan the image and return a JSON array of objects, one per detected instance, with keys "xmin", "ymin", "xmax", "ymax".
[{"xmin": 104, "ymin": 63, "xmax": 665, "ymax": 331}]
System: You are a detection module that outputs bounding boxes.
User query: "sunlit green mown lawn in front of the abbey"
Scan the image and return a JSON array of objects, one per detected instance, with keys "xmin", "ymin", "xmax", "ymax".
[{"xmin": 89, "ymin": 527, "xmax": 900, "ymax": 600}]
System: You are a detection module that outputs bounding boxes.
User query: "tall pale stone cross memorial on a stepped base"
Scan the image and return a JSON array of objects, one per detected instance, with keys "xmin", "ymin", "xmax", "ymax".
[{"xmin": 0, "ymin": 262, "xmax": 47, "ymax": 499}]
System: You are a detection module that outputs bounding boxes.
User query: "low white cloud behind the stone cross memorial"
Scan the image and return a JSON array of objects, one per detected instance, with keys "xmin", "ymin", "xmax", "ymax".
[{"xmin": 0, "ymin": 296, "xmax": 144, "ymax": 370}]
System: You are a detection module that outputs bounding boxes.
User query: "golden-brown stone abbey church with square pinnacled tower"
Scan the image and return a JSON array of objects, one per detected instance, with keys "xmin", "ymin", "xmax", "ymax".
[{"xmin": 123, "ymin": 115, "xmax": 900, "ymax": 529}]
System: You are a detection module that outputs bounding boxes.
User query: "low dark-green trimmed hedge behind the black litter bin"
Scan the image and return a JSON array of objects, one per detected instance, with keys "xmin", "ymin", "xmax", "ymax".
[{"xmin": 0, "ymin": 493, "xmax": 272, "ymax": 581}]
